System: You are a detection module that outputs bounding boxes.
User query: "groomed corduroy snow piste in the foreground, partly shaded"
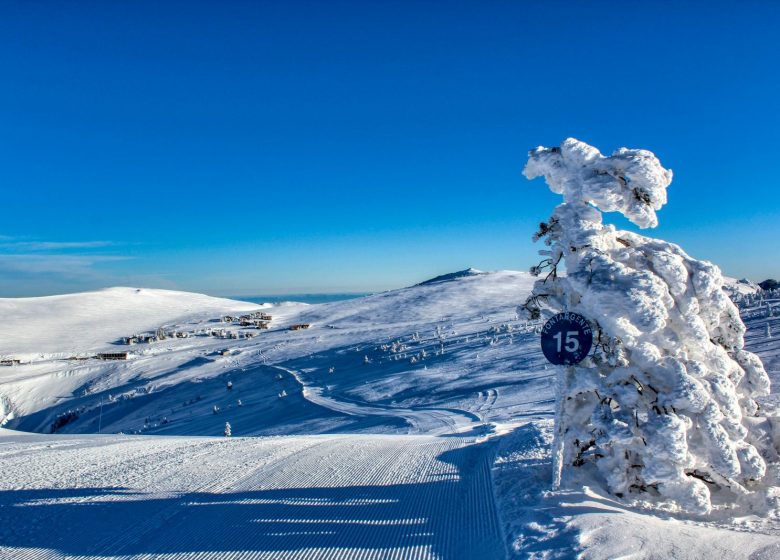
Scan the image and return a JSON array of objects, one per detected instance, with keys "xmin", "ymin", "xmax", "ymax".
[{"xmin": 0, "ymin": 434, "xmax": 505, "ymax": 560}]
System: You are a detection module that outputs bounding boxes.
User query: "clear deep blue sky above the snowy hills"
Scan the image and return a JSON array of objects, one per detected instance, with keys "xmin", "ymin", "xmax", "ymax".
[{"xmin": 0, "ymin": 0, "xmax": 780, "ymax": 296}]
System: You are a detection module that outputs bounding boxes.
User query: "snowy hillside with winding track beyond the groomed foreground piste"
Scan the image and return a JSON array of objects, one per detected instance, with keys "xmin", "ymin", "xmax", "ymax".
[{"xmin": 0, "ymin": 272, "xmax": 551, "ymax": 435}]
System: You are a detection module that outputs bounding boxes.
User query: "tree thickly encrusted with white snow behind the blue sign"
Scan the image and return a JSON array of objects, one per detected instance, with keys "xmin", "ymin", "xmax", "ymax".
[{"xmin": 523, "ymin": 138, "xmax": 777, "ymax": 513}]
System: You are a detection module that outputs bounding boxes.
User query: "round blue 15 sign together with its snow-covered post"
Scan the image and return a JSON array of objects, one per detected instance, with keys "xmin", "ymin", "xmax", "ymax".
[{"xmin": 542, "ymin": 311, "xmax": 593, "ymax": 490}]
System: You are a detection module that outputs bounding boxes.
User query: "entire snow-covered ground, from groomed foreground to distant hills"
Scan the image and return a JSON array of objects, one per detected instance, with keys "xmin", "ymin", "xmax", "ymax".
[{"xmin": 0, "ymin": 269, "xmax": 780, "ymax": 560}]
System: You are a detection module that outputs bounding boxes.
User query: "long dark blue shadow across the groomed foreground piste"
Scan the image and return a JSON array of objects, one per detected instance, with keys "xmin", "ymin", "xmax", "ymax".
[{"xmin": 0, "ymin": 444, "xmax": 505, "ymax": 559}]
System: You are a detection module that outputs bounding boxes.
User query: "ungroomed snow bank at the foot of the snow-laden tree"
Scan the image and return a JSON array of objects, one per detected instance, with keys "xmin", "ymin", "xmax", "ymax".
[{"xmin": 493, "ymin": 421, "xmax": 780, "ymax": 560}]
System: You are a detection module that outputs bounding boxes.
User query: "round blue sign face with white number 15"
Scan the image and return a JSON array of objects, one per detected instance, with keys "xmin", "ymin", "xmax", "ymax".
[{"xmin": 542, "ymin": 312, "xmax": 593, "ymax": 366}]
